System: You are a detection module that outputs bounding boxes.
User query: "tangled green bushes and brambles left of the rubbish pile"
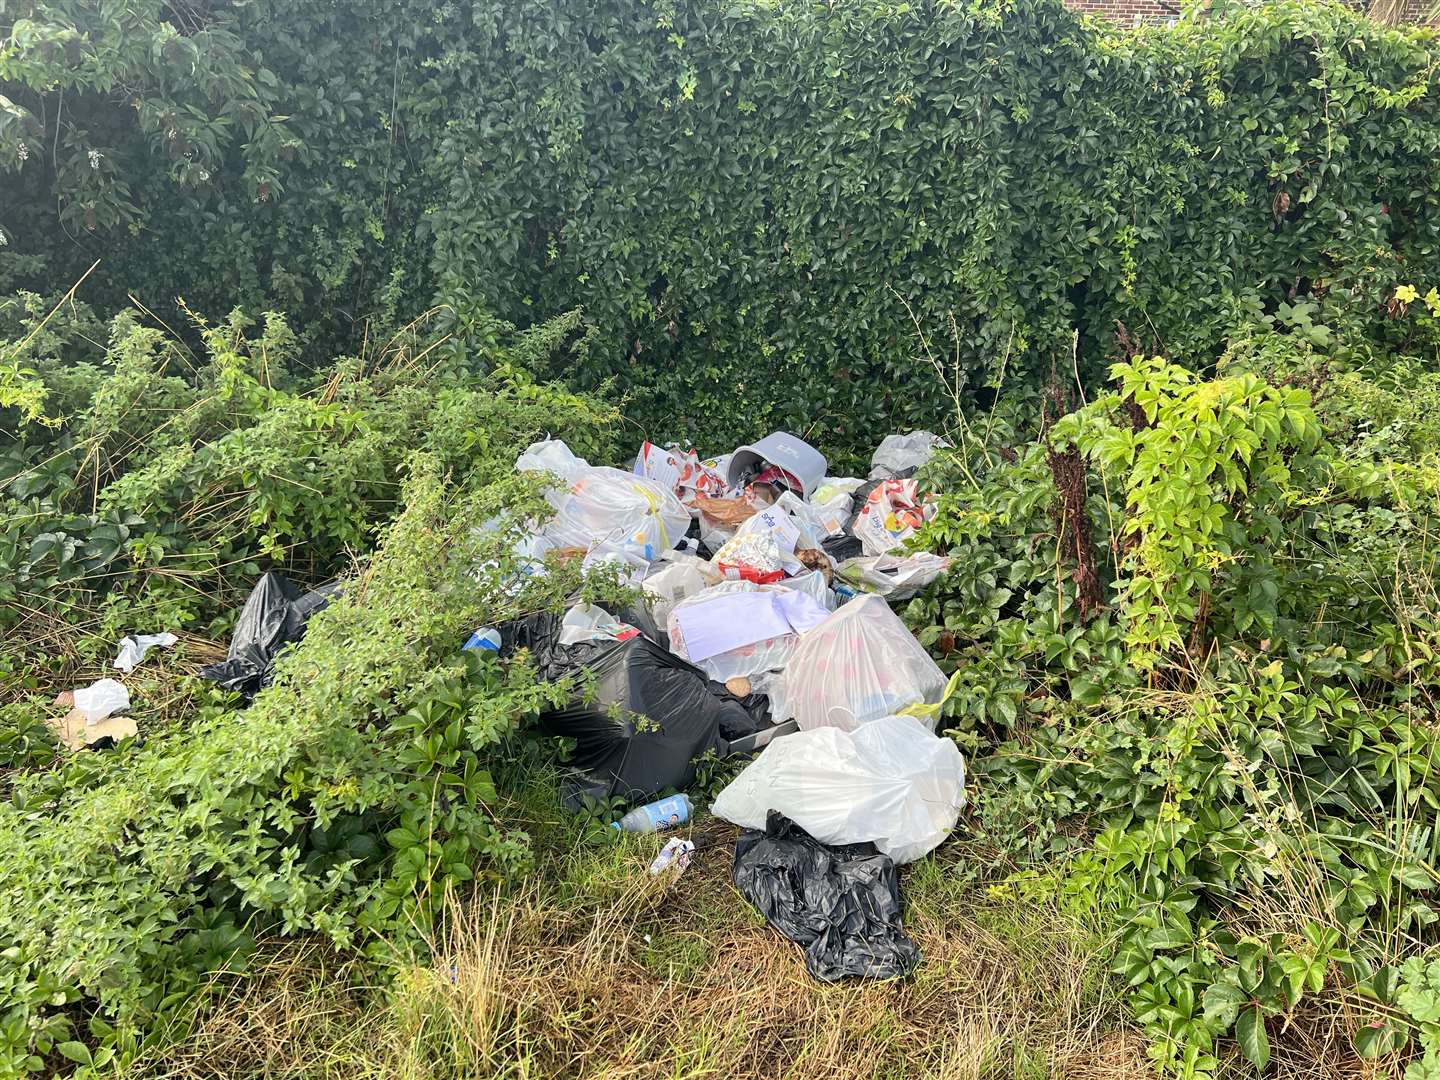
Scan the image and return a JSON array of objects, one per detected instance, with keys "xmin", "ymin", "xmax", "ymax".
[{"xmin": 0, "ymin": 300, "xmax": 630, "ymax": 1076}]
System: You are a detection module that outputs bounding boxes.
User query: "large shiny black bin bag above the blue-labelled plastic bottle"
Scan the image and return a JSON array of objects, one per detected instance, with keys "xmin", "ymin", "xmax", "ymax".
[{"xmin": 501, "ymin": 611, "xmax": 769, "ymax": 802}]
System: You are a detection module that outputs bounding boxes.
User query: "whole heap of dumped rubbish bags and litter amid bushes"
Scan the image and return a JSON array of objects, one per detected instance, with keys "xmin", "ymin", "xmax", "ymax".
[{"xmin": 483, "ymin": 432, "xmax": 965, "ymax": 981}]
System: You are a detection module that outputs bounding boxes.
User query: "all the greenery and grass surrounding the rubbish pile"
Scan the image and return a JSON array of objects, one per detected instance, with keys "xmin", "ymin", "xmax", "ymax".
[{"xmin": 0, "ymin": 0, "xmax": 1440, "ymax": 1080}]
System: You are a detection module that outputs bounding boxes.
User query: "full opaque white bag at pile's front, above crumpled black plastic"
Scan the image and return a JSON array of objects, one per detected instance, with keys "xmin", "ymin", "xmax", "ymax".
[{"xmin": 710, "ymin": 716, "xmax": 965, "ymax": 863}]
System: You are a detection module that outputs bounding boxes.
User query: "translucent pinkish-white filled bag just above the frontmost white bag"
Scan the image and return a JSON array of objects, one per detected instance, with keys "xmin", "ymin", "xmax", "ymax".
[{"xmin": 785, "ymin": 596, "xmax": 945, "ymax": 732}]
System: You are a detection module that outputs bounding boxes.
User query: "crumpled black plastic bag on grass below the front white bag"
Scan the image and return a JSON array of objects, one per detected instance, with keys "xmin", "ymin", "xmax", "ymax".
[{"xmin": 734, "ymin": 811, "xmax": 920, "ymax": 982}]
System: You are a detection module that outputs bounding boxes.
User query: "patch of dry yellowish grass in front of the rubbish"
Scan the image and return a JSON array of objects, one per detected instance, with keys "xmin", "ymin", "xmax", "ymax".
[{"xmin": 134, "ymin": 825, "xmax": 1148, "ymax": 1080}]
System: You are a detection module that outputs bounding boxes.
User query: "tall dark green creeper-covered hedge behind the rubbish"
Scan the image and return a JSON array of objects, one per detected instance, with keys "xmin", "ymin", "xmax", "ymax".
[{"xmin": 0, "ymin": 0, "xmax": 1440, "ymax": 448}]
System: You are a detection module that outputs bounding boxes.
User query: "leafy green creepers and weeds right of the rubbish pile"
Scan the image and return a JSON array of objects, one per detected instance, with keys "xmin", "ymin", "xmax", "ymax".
[{"xmin": 907, "ymin": 351, "xmax": 1440, "ymax": 1077}]
